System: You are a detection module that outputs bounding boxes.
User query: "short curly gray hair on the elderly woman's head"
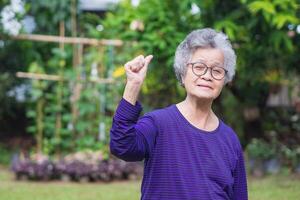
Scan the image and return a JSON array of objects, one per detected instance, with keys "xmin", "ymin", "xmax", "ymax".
[{"xmin": 174, "ymin": 28, "xmax": 236, "ymax": 85}]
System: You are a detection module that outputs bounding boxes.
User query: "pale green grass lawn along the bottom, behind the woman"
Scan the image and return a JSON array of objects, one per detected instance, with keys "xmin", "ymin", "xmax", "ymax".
[{"xmin": 0, "ymin": 168, "xmax": 300, "ymax": 200}]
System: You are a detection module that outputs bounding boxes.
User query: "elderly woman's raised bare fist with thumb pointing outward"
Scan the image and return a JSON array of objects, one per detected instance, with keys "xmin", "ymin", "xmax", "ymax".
[{"xmin": 124, "ymin": 55, "xmax": 153, "ymax": 84}]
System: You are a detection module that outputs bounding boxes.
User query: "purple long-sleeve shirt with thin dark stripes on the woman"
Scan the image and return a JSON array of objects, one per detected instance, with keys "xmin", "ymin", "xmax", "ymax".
[{"xmin": 110, "ymin": 99, "xmax": 248, "ymax": 200}]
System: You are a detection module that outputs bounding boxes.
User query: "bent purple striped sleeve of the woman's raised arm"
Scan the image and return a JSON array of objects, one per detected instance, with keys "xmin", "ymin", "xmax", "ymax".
[{"xmin": 110, "ymin": 98, "xmax": 157, "ymax": 161}]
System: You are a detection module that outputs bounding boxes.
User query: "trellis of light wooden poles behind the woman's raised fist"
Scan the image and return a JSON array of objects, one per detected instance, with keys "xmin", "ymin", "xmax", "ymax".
[{"xmin": 2, "ymin": 21, "xmax": 123, "ymax": 153}]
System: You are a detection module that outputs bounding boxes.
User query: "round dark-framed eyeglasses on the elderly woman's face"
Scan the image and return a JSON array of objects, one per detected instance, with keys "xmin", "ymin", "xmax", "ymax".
[{"xmin": 188, "ymin": 62, "xmax": 228, "ymax": 80}]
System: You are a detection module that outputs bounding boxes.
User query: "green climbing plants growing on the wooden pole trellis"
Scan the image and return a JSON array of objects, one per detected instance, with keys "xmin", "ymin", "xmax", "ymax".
[{"xmin": 22, "ymin": 43, "xmax": 116, "ymax": 154}]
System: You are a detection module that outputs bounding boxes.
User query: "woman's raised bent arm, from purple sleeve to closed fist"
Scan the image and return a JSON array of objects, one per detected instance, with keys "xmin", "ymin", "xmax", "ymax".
[{"xmin": 110, "ymin": 55, "xmax": 157, "ymax": 161}]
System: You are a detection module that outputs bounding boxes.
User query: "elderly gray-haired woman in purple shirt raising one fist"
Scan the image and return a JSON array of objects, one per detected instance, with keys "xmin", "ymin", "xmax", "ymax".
[{"xmin": 110, "ymin": 28, "xmax": 248, "ymax": 200}]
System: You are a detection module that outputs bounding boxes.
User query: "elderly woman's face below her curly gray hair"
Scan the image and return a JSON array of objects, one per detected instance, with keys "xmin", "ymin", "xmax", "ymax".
[{"xmin": 183, "ymin": 48, "xmax": 225, "ymax": 100}]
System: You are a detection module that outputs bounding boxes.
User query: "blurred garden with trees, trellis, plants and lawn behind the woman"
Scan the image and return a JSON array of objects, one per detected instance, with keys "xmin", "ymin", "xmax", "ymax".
[{"xmin": 0, "ymin": 0, "xmax": 300, "ymax": 200}]
